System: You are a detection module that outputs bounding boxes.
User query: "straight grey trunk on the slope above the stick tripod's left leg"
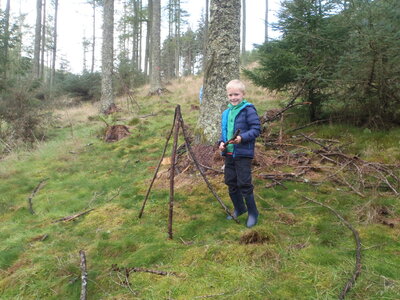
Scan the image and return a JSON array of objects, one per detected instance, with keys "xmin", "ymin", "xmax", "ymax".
[{"xmin": 150, "ymin": 0, "xmax": 162, "ymax": 94}]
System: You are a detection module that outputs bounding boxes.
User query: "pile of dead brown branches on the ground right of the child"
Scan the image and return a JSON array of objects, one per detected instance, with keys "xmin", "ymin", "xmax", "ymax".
[{"xmin": 259, "ymin": 134, "xmax": 400, "ymax": 197}]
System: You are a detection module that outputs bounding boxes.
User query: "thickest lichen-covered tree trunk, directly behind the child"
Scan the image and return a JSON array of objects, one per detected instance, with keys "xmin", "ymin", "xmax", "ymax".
[{"xmin": 197, "ymin": 0, "xmax": 240, "ymax": 143}]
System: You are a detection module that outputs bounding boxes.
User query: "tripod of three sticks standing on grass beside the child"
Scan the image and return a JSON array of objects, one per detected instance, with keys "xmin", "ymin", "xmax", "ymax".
[{"xmin": 139, "ymin": 105, "xmax": 239, "ymax": 239}]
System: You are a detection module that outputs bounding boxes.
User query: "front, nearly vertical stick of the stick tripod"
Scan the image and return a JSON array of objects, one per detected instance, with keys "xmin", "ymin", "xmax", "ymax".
[{"xmin": 168, "ymin": 105, "xmax": 181, "ymax": 240}]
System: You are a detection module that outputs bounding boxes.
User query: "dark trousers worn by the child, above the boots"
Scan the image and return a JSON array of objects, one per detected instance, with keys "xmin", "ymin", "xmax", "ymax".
[{"xmin": 224, "ymin": 155, "xmax": 254, "ymax": 197}]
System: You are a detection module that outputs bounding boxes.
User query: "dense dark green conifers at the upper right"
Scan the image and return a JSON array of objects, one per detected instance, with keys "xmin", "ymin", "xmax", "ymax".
[{"xmin": 246, "ymin": 0, "xmax": 400, "ymax": 127}]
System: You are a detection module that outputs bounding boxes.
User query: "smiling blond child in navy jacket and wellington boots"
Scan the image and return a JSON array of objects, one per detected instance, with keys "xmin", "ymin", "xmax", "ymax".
[{"xmin": 219, "ymin": 80, "xmax": 261, "ymax": 228}]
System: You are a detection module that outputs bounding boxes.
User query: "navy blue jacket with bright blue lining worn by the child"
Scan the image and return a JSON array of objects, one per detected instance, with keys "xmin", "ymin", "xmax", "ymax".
[{"xmin": 218, "ymin": 102, "xmax": 261, "ymax": 158}]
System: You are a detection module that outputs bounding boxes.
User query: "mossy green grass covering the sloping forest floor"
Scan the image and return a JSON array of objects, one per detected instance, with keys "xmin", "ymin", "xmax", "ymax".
[{"xmin": 0, "ymin": 77, "xmax": 400, "ymax": 300}]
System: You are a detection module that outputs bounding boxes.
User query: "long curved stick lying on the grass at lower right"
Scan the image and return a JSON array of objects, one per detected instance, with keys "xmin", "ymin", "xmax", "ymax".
[{"xmin": 295, "ymin": 191, "xmax": 362, "ymax": 299}]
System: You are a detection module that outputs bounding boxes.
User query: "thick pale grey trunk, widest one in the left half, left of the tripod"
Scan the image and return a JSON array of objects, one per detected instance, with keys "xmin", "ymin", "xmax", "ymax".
[{"xmin": 100, "ymin": 0, "xmax": 114, "ymax": 112}]
